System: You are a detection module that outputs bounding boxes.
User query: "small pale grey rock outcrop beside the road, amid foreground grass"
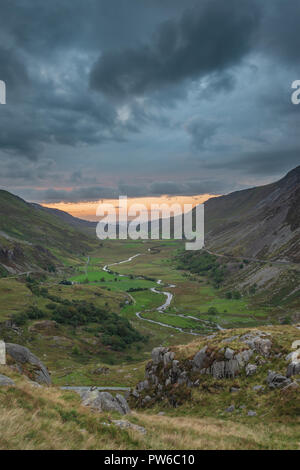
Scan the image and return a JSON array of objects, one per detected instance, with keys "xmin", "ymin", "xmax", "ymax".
[{"xmin": 81, "ymin": 389, "xmax": 130, "ymax": 415}]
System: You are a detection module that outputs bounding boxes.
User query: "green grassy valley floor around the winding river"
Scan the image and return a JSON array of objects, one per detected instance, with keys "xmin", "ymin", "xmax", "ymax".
[{"xmin": 0, "ymin": 240, "xmax": 282, "ymax": 385}]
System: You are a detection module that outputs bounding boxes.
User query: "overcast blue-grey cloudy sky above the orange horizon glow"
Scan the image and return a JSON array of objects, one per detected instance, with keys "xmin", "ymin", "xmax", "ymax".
[{"xmin": 0, "ymin": 0, "xmax": 300, "ymax": 203}]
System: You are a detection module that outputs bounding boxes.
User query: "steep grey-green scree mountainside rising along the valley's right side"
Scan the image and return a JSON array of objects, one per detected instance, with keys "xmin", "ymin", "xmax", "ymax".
[{"xmin": 181, "ymin": 166, "xmax": 300, "ymax": 312}]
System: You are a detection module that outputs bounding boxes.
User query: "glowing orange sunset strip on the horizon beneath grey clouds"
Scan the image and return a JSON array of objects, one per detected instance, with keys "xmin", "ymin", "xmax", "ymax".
[{"xmin": 42, "ymin": 194, "xmax": 216, "ymax": 221}]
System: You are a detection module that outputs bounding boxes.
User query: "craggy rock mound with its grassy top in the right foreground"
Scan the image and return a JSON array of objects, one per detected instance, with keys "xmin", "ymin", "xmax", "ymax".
[{"xmin": 131, "ymin": 327, "xmax": 300, "ymax": 407}]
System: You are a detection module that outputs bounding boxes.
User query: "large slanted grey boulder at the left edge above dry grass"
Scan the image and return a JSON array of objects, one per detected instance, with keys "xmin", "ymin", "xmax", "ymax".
[{"xmin": 5, "ymin": 343, "xmax": 51, "ymax": 385}]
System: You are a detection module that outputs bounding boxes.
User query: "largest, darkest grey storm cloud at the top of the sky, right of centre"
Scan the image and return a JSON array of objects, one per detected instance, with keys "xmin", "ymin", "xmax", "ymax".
[{"xmin": 91, "ymin": 0, "xmax": 259, "ymax": 98}]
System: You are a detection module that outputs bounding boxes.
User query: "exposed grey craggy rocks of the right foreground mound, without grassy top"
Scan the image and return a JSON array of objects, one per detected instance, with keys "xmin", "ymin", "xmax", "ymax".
[{"xmin": 130, "ymin": 330, "xmax": 300, "ymax": 407}]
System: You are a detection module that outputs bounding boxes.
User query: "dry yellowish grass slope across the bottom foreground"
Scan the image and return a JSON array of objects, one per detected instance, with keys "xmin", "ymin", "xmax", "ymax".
[{"xmin": 0, "ymin": 366, "xmax": 300, "ymax": 450}]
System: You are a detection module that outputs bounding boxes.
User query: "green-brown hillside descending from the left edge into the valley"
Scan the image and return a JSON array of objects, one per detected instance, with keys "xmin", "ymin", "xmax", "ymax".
[{"xmin": 0, "ymin": 190, "xmax": 97, "ymax": 275}]
